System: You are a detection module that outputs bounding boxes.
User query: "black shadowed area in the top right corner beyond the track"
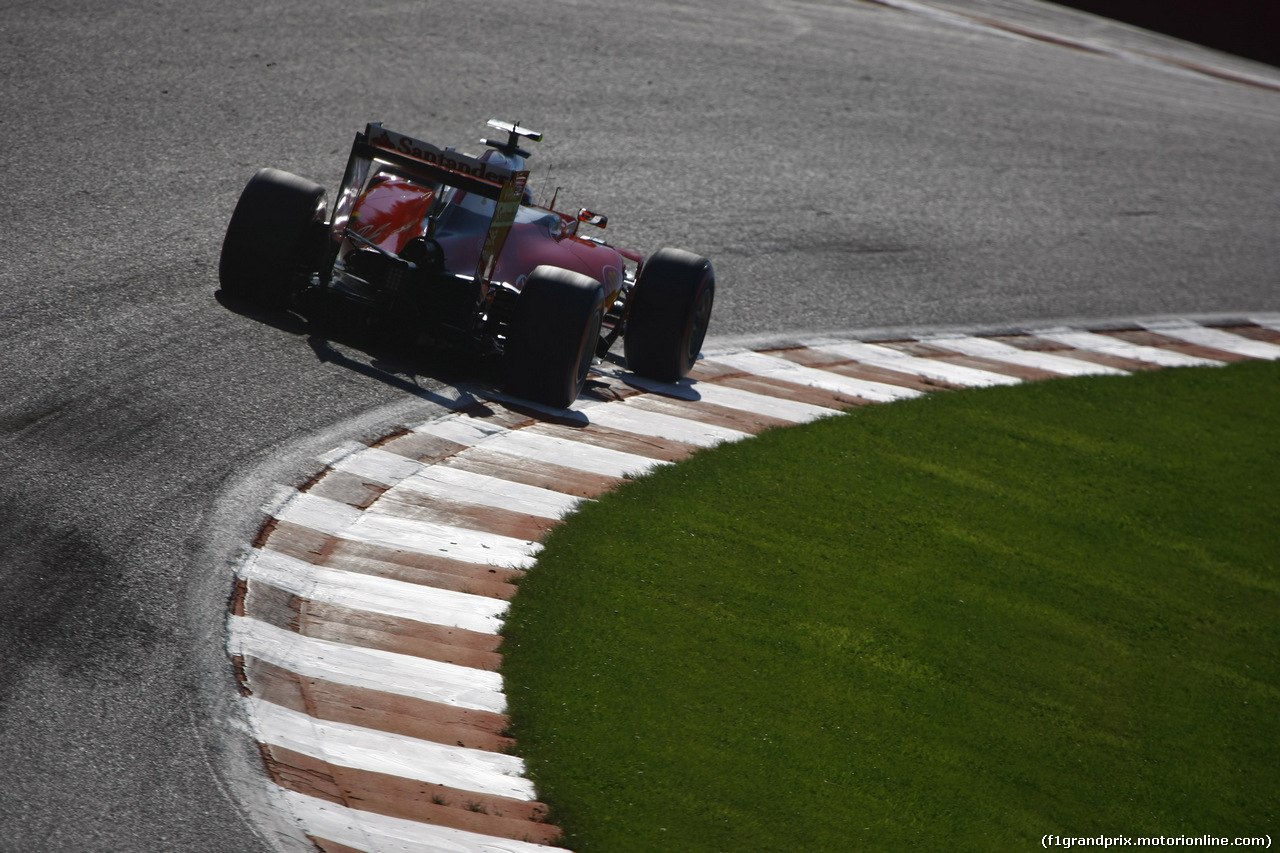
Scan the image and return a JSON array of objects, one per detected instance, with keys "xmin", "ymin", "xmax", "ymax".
[{"xmin": 1057, "ymin": 0, "xmax": 1280, "ymax": 67}]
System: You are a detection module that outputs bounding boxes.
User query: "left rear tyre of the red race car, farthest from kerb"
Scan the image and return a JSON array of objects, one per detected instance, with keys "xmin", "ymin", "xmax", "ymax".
[{"xmin": 218, "ymin": 169, "xmax": 328, "ymax": 309}]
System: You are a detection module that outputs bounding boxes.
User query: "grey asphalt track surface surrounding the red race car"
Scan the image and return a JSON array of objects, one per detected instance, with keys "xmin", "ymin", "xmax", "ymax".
[{"xmin": 0, "ymin": 0, "xmax": 1280, "ymax": 852}]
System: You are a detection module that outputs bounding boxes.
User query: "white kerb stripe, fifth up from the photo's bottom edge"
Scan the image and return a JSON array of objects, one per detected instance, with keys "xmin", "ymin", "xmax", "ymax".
[{"xmin": 275, "ymin": 492, "xmax": 541, "ymax": 569}]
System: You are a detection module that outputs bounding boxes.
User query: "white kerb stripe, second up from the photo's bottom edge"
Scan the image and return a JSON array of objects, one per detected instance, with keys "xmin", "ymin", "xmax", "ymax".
[{"xmin": 246, "ymin": 697, "xmax": 538, "ymax": 802}]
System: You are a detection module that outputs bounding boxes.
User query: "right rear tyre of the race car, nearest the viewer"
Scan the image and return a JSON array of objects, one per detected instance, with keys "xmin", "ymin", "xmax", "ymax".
[{"xmin": 503, "ymin": 266, "xmax": 604, "ymax": 409}]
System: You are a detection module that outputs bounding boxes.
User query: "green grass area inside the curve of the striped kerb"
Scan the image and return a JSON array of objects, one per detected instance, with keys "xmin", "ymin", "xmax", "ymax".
[{"xmin": 503, "ymin": 362, "xmax": 1280, "ymax": 853}]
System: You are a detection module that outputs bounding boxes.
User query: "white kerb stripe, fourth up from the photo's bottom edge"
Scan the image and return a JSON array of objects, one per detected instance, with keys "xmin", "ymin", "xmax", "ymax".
[{"xmin": 238, "ymin": 548, "xmax": 508, "ymax": 634}]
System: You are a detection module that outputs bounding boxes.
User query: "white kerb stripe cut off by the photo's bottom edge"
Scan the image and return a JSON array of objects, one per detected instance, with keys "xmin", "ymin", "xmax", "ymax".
[{"xmin": 284, "ymin": 790, "xmax": 568, "ymax": 853}]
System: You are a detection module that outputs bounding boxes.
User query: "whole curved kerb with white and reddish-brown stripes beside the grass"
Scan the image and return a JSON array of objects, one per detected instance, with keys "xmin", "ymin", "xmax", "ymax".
[{"xmin": 228, "ymin": 315, "xmax": 1280, "ymax": 853}]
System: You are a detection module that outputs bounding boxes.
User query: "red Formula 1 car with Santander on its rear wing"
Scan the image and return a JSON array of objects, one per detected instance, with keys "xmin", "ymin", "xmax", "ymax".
[{"xmin": 219, "ymin": 122, "xmax": 716, "ymax": 406}]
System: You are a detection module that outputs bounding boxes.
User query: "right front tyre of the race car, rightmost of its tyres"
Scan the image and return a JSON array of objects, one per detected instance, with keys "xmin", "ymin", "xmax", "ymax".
[{"xmin": 622, "ymin": 248, "xmax": 716, "ymax": 382}]
